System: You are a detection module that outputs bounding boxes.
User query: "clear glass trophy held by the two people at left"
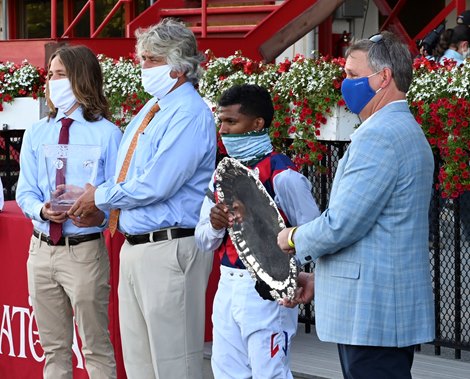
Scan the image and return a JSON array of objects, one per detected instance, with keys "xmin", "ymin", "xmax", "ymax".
[{"xmin": 44, "ymin": 144, "xmax": 101, "ymax": 212}]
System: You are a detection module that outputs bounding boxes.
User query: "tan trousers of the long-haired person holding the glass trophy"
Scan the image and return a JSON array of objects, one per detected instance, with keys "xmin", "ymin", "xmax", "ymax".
[{"xmin": 27, "ymin": 236, "xmax": 116, "ymax": 379}]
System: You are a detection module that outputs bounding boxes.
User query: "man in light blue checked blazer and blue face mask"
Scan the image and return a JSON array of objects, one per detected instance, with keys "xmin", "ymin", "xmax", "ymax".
[{"xmin": 278, "ymin": 32, "xmax": 434, "ymax": 379}]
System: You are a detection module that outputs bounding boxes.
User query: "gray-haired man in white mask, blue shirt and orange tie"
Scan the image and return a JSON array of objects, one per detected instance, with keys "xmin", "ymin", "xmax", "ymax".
[{"xmin": 69, "ymin": 19, "xmax": 216, "ymax": 379}]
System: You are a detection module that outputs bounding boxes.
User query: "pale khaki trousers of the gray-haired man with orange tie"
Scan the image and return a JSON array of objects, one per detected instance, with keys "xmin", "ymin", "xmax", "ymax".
[{"xmin": 118, "ymin": 237, "xmax": 213, "ymax": 379}]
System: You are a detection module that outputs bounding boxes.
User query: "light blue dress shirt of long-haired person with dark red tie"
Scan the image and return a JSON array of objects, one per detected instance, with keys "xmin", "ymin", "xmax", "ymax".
[{"xmin": 16, "ymin": 108, "xmax": 122, "ymax": 236}]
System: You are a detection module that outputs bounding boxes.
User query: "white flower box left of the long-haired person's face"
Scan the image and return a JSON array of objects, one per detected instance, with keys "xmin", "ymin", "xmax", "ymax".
[{"xmin": 0, "ymin": 97, "xmax": 43, "ymax": 129}]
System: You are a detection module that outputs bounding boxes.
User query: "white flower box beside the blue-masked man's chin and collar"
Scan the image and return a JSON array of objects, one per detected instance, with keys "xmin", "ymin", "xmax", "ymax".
[{"xmin": 318, "ymin": 106, "xmax": 361, "ymax": 141}]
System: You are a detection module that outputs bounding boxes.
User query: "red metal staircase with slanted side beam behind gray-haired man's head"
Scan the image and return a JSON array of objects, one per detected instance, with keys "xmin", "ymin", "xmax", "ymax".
[{"xmin": 127, "ymin": 0, "xmax": 344, "ymax": 61}]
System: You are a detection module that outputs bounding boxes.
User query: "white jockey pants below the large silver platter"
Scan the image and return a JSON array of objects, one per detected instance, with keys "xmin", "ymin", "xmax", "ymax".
[{"xmin": 211, "ymin": 266, "xmax": 298, "ymax": 379}]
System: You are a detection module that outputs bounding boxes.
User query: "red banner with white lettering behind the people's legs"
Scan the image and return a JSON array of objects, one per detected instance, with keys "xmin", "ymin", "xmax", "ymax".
[{"xmin": 0, "ymin": 201, "xmax": 219, "ymax": 379}]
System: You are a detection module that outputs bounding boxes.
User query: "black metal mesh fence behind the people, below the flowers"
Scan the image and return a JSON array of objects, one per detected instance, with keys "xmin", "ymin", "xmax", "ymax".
[{"xmin": 0, "ymin": 134, "xmax": 470, "ymax": 358}]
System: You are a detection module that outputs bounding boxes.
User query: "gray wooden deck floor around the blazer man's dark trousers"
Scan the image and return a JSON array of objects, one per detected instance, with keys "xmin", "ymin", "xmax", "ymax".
[{"xmin": 205, "ymin": 325, "xmax": 470, "ymax": 379}]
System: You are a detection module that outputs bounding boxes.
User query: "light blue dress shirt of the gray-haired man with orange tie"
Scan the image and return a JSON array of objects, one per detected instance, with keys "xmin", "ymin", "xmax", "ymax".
[{"xmin": 95, "ymin": 82, "xmax": 216, "ymax": 234}]
